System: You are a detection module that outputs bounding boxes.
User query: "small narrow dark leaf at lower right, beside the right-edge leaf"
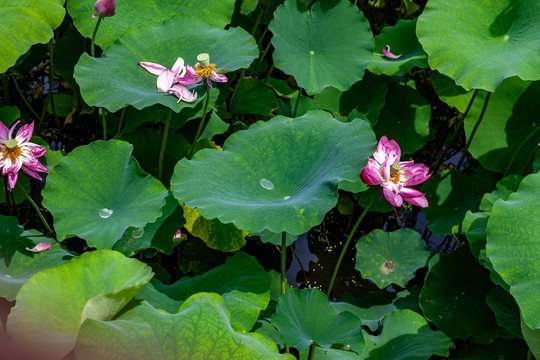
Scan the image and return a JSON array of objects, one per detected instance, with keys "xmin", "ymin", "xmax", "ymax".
[{"xmin": 486, "ymin": 286, "xmax": 523, "ymax": 338}]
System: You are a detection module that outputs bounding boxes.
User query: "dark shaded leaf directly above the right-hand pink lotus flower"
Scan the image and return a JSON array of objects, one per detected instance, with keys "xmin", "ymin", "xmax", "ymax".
[{"xmin": 375, "ymin": 81, "xmax": 431, "ymax": 154}]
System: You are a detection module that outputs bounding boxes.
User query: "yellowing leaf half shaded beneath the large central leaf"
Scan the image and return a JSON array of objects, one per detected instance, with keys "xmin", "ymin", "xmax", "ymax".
[{"xmin": 183, "ymin": 205, "xmax": 249, "ymax": 252}]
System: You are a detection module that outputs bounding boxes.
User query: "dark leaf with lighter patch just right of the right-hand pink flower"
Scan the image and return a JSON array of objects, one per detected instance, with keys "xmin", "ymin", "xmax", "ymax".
[{"xmin": 421, "ymin": 170, "xmax": 478, "ymax": 236}]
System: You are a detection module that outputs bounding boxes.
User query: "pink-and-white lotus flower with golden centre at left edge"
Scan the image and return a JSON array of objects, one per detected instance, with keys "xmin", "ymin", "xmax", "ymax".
[{"xmin": 0, "ymin": 121, "xmax": 49, "ymax": 191}]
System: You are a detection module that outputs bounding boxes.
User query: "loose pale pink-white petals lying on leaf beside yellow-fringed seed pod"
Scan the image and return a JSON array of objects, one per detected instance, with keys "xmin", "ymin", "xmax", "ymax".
[{"xmin": 138, "ymin": 57, "xmax": 197, "ymax": 102}]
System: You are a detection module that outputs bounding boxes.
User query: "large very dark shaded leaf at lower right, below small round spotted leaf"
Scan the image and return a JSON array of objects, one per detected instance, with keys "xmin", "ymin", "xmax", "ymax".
[{"xmin": 420, "ymin": 247, "xmax": 495, "ymax": 339}]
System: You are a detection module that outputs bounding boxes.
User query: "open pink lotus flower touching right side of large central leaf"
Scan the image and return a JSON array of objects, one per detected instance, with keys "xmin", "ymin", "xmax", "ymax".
[{"xmin": 360, "ymin": 136, "xmax": 431, "ymax": 207}]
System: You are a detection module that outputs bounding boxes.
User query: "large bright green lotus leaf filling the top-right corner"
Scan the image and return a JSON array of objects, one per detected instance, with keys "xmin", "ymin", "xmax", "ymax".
[{"xmin": 416, "ymin": 0, "xmax": 540, "ymax": 92}]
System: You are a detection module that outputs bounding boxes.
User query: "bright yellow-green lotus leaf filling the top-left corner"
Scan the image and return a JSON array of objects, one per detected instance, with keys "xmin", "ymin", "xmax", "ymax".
[{"xmin": 0, "ymin": 0, "xmax": 66, "ymax": 74}]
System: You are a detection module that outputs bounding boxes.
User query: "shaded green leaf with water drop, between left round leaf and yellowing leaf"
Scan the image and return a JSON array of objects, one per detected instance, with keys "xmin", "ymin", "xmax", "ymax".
[{"xmin": 113, "ymin": 194, "xmax": 185, "ymax": 257}]
